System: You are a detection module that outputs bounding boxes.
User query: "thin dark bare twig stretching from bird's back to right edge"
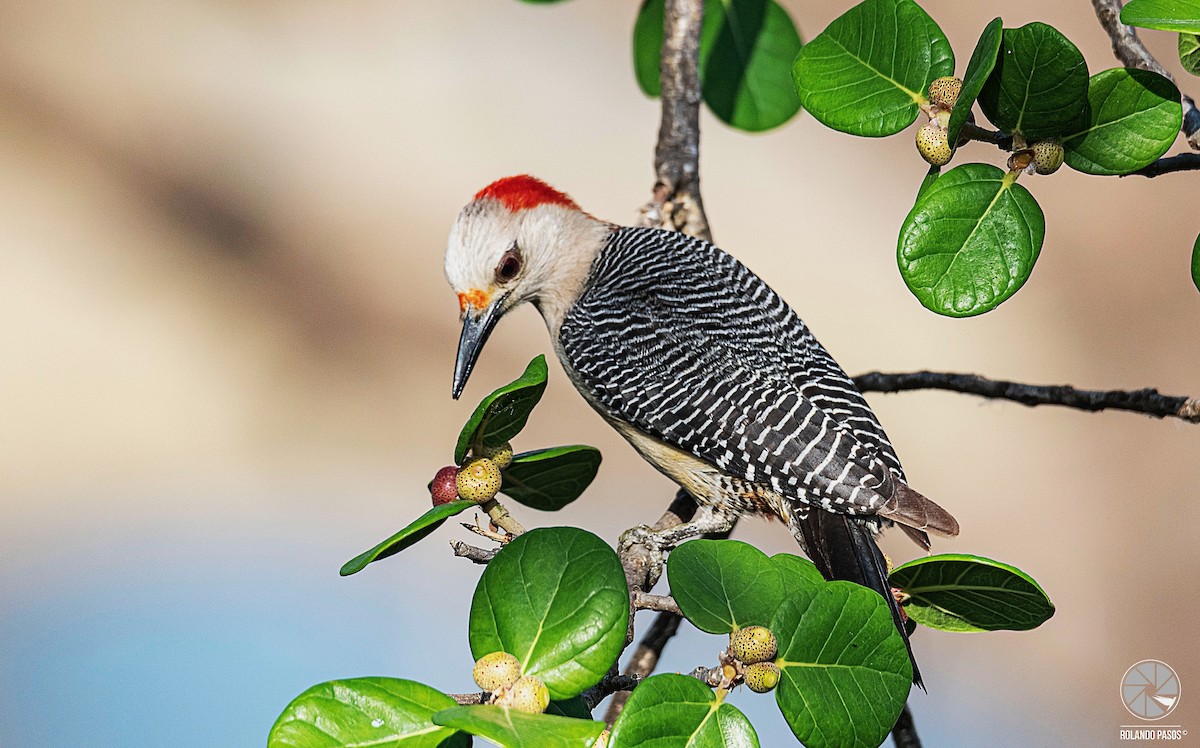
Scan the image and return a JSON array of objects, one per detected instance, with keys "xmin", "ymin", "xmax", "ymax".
[{"xmin": 854, "ymin": 371, "xmax": 1200, "ymax": 424}]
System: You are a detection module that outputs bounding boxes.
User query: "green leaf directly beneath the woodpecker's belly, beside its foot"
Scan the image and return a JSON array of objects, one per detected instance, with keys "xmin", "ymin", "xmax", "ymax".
[{"xmin": 667, "ymin": 540, "xmax": 784, "ymax": 634}]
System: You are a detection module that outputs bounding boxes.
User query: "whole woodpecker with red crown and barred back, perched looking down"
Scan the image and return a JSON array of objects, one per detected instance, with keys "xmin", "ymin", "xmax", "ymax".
[{"xmin": 445, "ymin": 175, "xmax": 959, "ymax": 684}]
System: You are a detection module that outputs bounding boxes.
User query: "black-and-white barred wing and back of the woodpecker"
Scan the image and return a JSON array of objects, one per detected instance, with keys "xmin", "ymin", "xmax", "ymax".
[{"xmin": 559, "ymin": 229, "xmax": 893, "ymax": 514}]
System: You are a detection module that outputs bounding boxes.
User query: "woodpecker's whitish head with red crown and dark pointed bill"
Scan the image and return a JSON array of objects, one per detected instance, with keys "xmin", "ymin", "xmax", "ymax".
[{"xmin": 445, "ymin": 175, "xmax": 613, "ymax": 397}]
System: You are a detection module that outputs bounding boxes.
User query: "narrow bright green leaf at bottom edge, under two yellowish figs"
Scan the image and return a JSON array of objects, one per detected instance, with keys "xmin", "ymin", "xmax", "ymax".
[{"xmin": 433, "ymin": 706, "xmax": 605, "ymax": 748}]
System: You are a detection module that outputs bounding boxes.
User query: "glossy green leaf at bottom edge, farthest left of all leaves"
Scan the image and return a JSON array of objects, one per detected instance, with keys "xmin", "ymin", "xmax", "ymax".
[{"xmin": 266, "ymin": 677, "xmax": 470, "ymax": 748}]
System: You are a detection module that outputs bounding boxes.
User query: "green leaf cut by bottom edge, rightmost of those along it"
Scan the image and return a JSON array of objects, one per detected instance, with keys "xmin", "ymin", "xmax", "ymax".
[{"xmin": 608, "ymin": 674, "xmax": 758, "ymax": 748}]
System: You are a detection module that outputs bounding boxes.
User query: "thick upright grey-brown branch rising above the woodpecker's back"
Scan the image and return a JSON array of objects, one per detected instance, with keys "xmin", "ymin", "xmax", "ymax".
[{"xmin": 638, "ymin": 0, "xmax": 713, "ymax": 241}]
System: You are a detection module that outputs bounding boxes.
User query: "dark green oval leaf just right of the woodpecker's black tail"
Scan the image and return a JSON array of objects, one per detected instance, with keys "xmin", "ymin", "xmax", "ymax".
[{"xmin": 892, "ymin": 553, "xmax": 1054, "ymax": 632}]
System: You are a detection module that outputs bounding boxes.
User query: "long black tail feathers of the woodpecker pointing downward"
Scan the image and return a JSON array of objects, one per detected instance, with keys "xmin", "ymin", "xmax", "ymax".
[{"xmin": 797, "ymin": 509, "xmax": 925, "ymax": 690}]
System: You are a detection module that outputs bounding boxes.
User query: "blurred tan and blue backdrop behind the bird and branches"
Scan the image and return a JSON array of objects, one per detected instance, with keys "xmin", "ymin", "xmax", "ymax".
[{"xmin": 0, "ymin": 0, "xmax": 1200, "ymax": 748}]
